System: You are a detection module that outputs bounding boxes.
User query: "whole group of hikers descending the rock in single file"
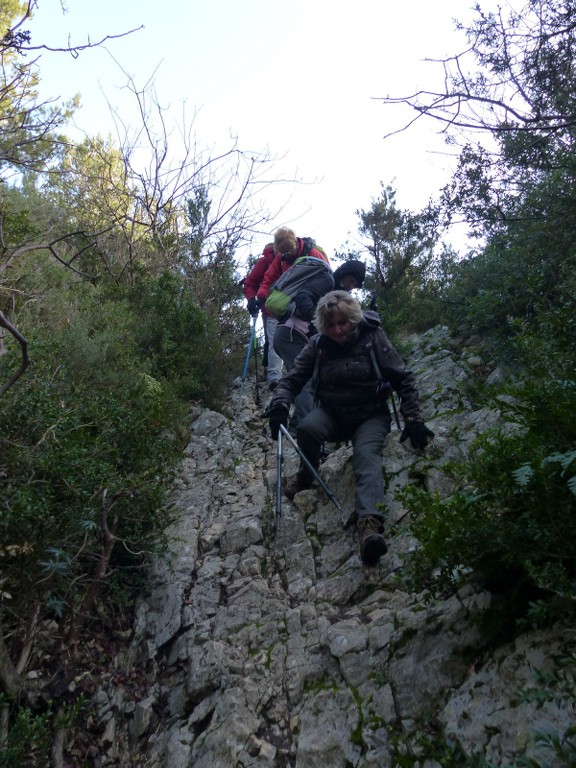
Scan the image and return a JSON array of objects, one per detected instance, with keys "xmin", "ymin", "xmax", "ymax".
[{"xmin": 243, "ymin": 228, "xmax": 434, "ymax": 565}]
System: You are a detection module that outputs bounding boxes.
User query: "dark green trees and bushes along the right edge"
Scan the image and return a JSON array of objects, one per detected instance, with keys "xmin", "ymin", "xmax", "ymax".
[{"xmin": 392, "ymin": 2, "xmax": 576, "ymax": 631}]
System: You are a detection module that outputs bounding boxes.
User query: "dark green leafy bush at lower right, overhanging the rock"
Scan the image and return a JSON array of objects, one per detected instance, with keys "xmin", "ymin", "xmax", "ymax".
[{"xmin": 398, "ymin": 368, "xmax": 576, "ymax": 630}]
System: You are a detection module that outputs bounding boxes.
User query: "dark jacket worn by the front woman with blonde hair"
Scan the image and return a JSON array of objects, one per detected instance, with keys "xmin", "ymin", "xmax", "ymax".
[{"xmin": 270, "ymin": 310, "xmax": 421, "ymax": 421}]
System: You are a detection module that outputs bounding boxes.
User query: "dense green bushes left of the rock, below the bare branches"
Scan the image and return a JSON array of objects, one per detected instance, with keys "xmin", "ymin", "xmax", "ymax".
[{"xmin": 0, "ymin": 244, "xmax": 254, "ymax": 658}]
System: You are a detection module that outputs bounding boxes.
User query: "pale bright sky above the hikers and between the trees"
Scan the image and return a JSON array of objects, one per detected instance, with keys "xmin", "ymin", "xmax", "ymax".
[{"xmin": 29, "ymin": 0, "xmax": 486, "ymax": 266}]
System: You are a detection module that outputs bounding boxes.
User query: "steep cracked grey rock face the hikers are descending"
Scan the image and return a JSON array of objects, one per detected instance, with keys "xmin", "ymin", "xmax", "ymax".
[{"xmin": 96, "ymin": 328, "xmax": 570, "ymax": 768}]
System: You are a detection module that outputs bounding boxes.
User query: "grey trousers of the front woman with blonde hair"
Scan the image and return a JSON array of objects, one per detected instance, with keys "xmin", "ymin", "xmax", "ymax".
[{"xmin": 297, "ymin": 407, "xmax": 390, "ymax": 519}]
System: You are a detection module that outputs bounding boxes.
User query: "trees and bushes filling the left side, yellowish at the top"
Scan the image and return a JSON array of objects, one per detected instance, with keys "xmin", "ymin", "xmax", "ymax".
[{"xmin": 0, "ymin": 2, "xmax": 255, "ymax": 756}]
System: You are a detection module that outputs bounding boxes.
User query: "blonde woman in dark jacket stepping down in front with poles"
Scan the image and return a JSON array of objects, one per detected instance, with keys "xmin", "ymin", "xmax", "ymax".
[{"xmin": 268, "ymin": 291, "xmax": 433, "ymax": 565}]
